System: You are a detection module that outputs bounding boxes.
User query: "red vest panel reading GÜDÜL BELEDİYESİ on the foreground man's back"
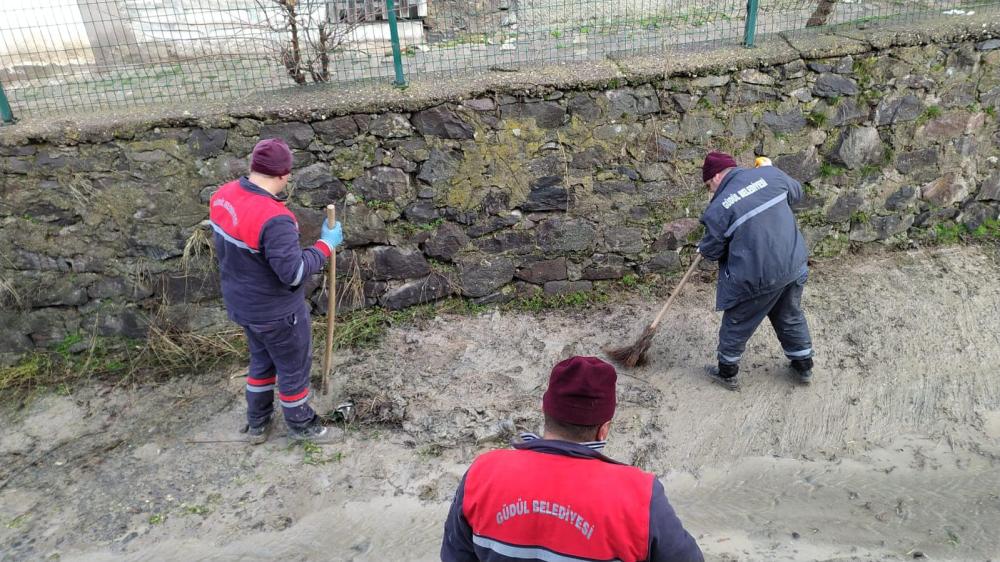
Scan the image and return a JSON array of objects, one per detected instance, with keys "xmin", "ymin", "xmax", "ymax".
[{"xmin": 462, "ymin": 450, "xmax": 654, "ymax": 562}]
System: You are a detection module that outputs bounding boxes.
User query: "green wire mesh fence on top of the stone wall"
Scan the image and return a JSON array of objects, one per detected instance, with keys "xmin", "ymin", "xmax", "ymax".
[{"xmin": 0, "ymin": 0, "xmax": 1000, "ymax": 122}]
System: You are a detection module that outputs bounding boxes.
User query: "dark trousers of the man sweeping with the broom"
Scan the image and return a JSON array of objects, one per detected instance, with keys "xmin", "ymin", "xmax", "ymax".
[{"xmin": 719, "ymin": 274, "xmax": 813, "ymax": 365}]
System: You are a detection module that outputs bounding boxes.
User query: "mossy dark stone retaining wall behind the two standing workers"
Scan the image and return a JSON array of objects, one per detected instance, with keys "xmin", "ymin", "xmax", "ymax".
[{"xmin": 0, "ymin": 19, "xmax": 1000, "ymax": 361}]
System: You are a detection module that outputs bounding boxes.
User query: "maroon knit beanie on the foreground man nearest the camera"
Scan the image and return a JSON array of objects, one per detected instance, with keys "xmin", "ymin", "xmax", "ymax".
[{"xmin": 542, "ymin": 357, "xmax": 618, "ymax": 425}]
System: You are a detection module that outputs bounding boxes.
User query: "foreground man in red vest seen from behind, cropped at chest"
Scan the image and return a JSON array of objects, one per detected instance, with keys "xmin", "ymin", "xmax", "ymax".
[{"xmin": 441, "ymin": 357, "xmax": 704, "ymax": 562}]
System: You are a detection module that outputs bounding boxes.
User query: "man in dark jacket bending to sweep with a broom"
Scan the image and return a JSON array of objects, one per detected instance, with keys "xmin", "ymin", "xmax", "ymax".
[{"xmin": 698, "ymin": 152, "xmax": 813, "ymax": 390}]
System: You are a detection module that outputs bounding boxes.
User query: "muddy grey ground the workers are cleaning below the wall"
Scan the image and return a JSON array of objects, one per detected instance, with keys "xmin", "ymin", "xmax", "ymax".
[{"xmin": 0, "ymin": 247, "xmax": 1000, "ymax": 560}]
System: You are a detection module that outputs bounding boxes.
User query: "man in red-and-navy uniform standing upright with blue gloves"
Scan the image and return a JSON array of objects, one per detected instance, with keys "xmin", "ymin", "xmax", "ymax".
[{"xmin": 209, "ymin": 139, "xmax": 344, "ymax": 444}]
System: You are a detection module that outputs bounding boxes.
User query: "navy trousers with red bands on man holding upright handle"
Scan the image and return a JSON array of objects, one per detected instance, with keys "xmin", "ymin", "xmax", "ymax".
[{"xmin": 243, "ymin": 302, "xmax": 316, "ymax": 428}]
